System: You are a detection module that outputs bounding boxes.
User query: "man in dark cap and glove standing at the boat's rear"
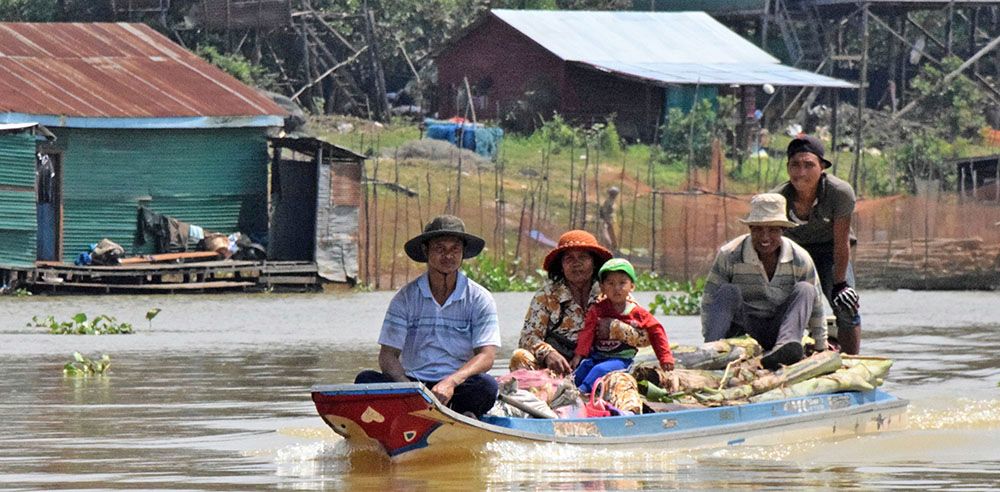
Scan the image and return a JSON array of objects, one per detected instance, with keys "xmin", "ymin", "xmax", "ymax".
[{"xmin": 772, "ymin": 135, "xmax": 861, "ymax": 354}]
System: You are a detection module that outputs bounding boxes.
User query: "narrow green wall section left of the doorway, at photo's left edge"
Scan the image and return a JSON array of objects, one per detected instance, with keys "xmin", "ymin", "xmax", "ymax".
[{"xmin": 0, "ymin": 132, "xmax": 37, "ymax": 266}]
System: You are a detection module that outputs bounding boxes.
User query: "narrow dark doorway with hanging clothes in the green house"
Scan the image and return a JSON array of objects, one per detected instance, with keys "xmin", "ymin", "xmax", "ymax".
[{"xmin": 35, "ymin": 152, "xmax": 62, "ymax": 261}]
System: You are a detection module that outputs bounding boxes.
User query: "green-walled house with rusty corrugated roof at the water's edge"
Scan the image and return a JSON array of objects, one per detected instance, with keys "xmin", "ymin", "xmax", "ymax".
[{"xmin": 0, "ymin": 23, "xmax": 285, "ymax": 266}]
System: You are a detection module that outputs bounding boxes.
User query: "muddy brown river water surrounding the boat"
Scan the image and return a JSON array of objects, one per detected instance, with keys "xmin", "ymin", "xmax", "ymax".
[{"xmin": 0, "ymin": 291, "xmax": 1000, "ymax": 491}]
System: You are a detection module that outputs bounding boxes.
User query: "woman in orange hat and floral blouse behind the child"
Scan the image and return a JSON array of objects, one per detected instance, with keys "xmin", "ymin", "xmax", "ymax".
[{"xmin": 510, "ymin": 230, "xmax": 649, "ymax": 374}]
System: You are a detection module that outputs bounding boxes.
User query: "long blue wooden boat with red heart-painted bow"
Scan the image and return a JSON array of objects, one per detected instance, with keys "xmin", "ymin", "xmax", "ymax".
[{"xmin": 312, "ymin": 383, "xmax": 908, "ymax": 461}]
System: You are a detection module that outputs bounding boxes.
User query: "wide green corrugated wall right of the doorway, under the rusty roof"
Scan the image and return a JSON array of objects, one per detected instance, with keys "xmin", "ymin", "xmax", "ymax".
[{"xmin": 50, "ymin": 128, "xmax": 268, "ymax": 261}]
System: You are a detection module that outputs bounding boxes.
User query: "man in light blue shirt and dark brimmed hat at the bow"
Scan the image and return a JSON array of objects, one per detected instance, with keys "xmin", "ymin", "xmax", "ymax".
[{"xmin": 354, "ymin": 215, "xmax": 500, "ymax": 417}]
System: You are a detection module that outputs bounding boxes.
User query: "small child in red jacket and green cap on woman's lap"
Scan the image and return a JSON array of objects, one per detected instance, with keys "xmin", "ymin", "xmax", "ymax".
[{"xmin": 570, "ymin": 258, "xmax": 674, "ymax": 393}]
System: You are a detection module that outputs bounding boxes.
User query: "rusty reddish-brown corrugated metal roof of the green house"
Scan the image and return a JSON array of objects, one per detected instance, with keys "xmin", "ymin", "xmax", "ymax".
[{"xmin": 0, "ymin": 23, "xmax": 285, "ymax": 126}]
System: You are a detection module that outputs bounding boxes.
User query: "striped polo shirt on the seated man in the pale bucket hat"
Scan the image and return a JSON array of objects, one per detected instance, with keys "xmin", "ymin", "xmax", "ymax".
[{"xmin": 702, "ymin": 234, "xmax": 826, "ymax": 334}]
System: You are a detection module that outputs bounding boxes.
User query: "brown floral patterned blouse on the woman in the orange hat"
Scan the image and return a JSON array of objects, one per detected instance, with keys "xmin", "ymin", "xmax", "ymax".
[{"xmin": 517, "ymin": 279, "xmax": 649, "ymax": 361}]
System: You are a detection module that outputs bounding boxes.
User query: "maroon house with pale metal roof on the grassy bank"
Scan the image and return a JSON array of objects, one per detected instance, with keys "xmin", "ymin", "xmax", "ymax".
[{"xmin": 434, "ymin": 10, "xmax": 854, "ymax": 141}]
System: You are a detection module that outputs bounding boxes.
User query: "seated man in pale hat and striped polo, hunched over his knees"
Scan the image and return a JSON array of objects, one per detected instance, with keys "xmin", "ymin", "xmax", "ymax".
[{"xmin": 701, "ymin": 193, "xmax": 826, "ymax": 370}]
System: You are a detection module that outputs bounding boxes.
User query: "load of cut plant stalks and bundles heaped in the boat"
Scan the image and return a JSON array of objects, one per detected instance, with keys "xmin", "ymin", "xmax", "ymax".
[{"xmin": 491, "ymin": 336, "xmax": 892, "ymax": 418}]
